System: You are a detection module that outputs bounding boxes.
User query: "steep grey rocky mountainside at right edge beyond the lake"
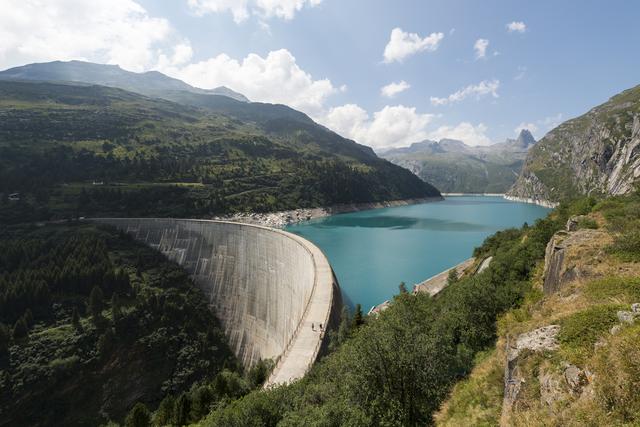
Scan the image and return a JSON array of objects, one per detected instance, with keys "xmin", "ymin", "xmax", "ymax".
[{"xmin": 508, "ymin": 86, "xmax": 640, "ymax": 202}]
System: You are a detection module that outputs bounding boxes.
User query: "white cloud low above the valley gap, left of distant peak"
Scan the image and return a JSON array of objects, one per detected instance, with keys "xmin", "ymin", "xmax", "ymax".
[{"xmin": 322, "ymin": 104, "xmax": 434, "ymax": 149}]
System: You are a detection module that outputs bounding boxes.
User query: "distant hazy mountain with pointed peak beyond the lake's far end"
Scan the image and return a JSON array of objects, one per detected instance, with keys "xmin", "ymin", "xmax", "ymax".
[{"xmin": 381, "ymin": 129, "xmax": 536, "ymax": 193}]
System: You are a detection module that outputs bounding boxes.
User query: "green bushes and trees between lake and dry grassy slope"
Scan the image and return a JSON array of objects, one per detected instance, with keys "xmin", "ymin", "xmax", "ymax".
[{"xmin": 174, "ymin": 195, "xmax": 571, "ymax": 426}]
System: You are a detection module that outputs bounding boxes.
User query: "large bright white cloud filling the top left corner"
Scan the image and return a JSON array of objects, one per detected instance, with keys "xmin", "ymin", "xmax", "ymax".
[{"xmin": 0, "ymin": 0, "xmax": 178, "ymax": 71}]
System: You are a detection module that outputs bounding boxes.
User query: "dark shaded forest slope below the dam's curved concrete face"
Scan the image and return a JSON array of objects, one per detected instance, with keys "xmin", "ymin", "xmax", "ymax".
[{"xmin": 0, "ymin": 225, "xmax": 239, "ymax": 426}]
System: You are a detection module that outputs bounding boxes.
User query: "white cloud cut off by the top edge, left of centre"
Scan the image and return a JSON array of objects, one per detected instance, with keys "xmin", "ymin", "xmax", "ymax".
[{"xmin": 187, "ymin": 0, "xmax": 322, "ymax": 23}]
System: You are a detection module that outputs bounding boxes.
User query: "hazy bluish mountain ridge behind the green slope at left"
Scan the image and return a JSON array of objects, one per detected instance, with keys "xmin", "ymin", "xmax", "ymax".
[{"xmin": 0, "ymin": 61, "xmax": 249, "ymax": 102}]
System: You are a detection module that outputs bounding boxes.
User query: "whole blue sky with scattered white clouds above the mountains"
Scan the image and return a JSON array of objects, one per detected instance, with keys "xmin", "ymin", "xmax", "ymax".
[{"xmin": 0, "ymin": 0, "xmax": 640, "ymax": 150}]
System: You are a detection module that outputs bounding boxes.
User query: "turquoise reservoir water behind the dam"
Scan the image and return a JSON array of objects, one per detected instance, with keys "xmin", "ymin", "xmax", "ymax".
[{"xmin": 286, "ymin": 196, "xmax": 549, "ymax": 311}]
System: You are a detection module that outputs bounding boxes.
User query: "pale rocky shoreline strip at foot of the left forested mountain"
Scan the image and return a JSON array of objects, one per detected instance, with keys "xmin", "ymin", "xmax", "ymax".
[{"xmin": 213, "ymin": 197, "xmax": 444, "ymax": 228}]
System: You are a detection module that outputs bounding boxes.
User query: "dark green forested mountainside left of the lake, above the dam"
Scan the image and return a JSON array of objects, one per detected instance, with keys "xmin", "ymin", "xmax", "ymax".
[{"xmin": 0, "ymin": 80, "xmax": 439, "ymax": 222}]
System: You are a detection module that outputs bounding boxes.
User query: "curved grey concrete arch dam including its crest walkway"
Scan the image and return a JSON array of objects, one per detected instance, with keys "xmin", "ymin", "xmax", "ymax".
[{"xmin": 97, "ymin": 218, "xmax": 342, "ymax": 387}]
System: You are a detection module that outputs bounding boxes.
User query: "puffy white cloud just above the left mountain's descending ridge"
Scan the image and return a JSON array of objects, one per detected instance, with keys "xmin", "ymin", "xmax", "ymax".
[{"xmin": 165, "ymin": 49, "xmax": 346, "ymax": 116}]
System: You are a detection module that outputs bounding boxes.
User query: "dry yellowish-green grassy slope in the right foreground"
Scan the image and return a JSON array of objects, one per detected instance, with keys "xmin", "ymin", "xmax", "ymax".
[{"xmin": 436, "ymin": 192, "xmax": 640, "ymax": 426}]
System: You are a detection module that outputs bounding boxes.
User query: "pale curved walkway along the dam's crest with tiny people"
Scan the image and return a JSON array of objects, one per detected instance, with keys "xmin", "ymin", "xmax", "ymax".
[{"xmin": 265, "ymin": 230, "xmax": 339, "ymax": 388}]
